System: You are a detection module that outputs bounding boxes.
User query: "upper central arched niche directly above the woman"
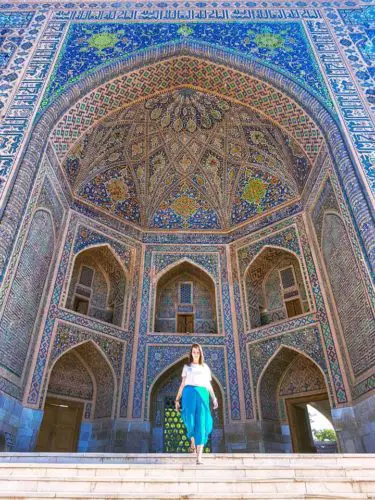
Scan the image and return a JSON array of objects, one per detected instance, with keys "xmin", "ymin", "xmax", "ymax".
[{"xmin": 154, "ymin": 262, "xmax": 217, "ymax": 333}]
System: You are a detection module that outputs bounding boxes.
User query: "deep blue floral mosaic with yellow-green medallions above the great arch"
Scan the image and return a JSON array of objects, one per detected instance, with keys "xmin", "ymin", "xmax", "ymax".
[{"xmin": 42, "ymin": 22, "xmax": 332, "ymax": 107}]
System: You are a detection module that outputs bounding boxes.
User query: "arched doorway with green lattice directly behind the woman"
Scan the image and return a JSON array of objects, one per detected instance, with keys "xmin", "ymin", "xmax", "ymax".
[{"xmin": 150, "ymin": 359, "xmax": 224, "ymax": 453}]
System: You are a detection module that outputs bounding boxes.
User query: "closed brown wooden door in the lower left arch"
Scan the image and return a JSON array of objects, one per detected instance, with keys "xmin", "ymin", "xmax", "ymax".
[{"xmin": 35, "ymin": 398, "xmax": 83, "ymax": 453}]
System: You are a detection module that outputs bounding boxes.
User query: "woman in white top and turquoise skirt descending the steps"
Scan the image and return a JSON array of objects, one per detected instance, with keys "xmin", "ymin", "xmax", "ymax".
[{"xmin": 175, "ymin": 344, "xmax": 218, "ymax": 464}]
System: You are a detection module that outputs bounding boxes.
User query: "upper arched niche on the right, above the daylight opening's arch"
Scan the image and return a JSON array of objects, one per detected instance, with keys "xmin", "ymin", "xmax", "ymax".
[{"xmin": 245, "ymin": 247, "xmax": 309, "ymax": 328}]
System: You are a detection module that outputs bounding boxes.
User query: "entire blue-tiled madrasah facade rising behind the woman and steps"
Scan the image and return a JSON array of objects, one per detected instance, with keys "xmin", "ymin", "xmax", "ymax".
[{"xmin": 0, "ymin": 0, "xmax": 375, "ymax": 452}]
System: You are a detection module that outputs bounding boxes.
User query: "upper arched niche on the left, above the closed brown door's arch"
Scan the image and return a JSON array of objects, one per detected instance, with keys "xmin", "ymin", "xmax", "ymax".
[{"xmin": 66, "ymin": 246, "xmax": 126, "ymax": 326}]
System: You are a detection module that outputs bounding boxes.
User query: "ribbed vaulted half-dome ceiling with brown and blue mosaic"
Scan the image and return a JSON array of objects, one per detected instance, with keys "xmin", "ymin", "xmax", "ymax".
[{"xmin": 64, "ymin": 87, "xmax": 311, "ymax": 230}]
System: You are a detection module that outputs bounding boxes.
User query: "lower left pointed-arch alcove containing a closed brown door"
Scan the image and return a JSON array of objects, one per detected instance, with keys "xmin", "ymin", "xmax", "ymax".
[{"xmin": 35, "ymin": 341, "xmax": 116, "ymax": 452}]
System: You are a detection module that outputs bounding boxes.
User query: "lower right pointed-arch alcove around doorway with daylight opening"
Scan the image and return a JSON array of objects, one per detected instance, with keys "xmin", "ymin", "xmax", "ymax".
[{"xmin": 258, "ymin": 346, "xmax": 331, "ymax": 453}]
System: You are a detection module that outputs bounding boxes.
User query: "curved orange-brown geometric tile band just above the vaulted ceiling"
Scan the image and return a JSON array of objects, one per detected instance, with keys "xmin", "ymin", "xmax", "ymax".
[{"xmin": 51, "ymin": 56, "xmax": 323, "ymax": 166}]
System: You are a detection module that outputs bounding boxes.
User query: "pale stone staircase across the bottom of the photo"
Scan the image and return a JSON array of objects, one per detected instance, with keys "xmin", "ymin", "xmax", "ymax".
[{"xmin": 0, "ymin": 453, "xmax": 375, "ymax": 500}]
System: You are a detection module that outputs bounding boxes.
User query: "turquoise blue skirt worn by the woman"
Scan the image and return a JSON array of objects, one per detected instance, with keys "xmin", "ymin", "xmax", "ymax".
[{"xmin": 181, "ymin": 385, "xmax": 213, "ymax": 446}]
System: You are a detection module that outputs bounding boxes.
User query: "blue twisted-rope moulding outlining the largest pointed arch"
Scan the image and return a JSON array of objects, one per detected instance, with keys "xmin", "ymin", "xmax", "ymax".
[{"xmin": 1, "ymin": 46, "xmax": 374, "ymax": 278}]
